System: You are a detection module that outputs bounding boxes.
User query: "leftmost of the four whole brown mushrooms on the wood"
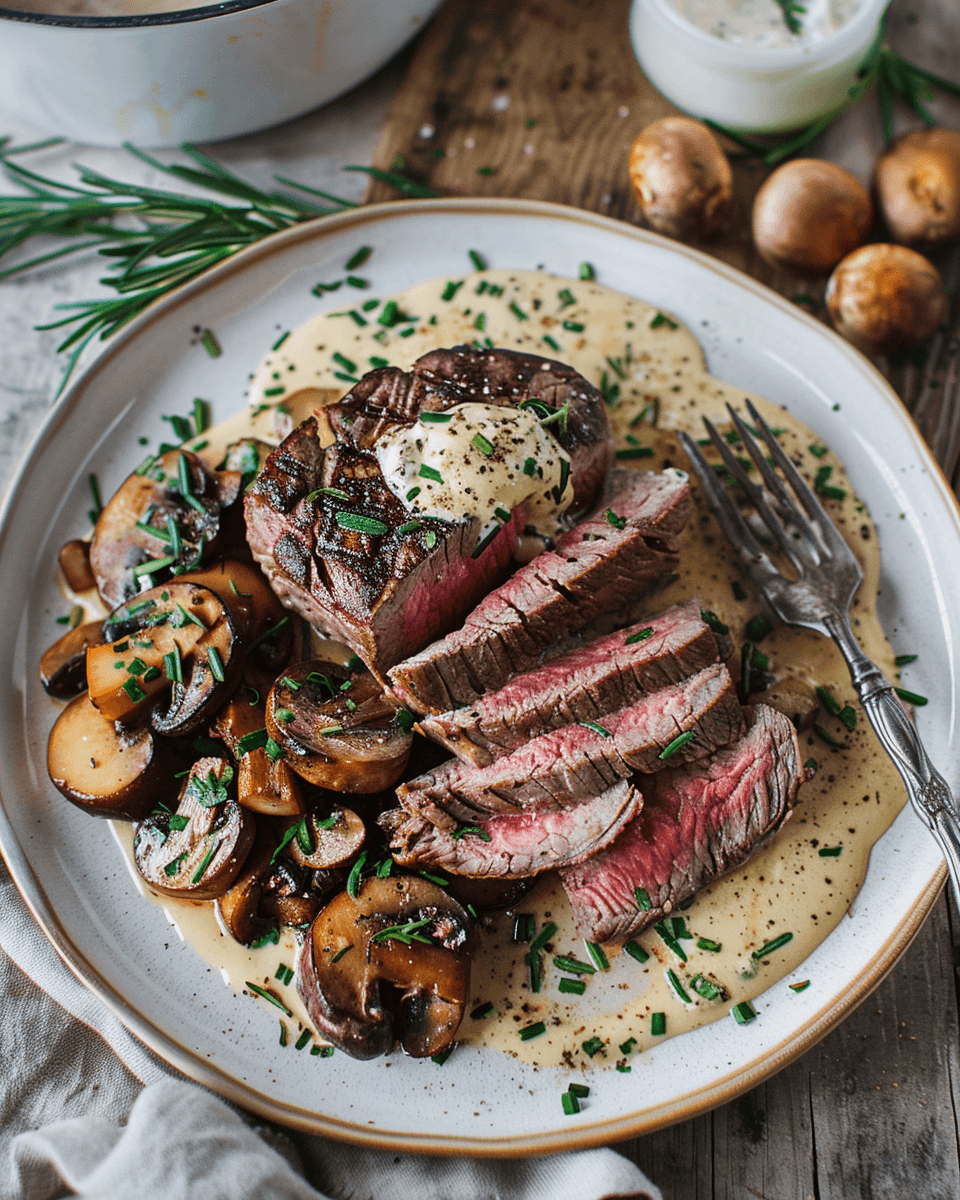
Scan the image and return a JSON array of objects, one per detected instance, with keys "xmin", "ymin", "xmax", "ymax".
[{"xmin": 629, "ymin": 116, "xmax": 733, "ymax": 240}]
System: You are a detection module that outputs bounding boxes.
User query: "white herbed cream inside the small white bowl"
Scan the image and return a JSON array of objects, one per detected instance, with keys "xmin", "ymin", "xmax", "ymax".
[{"xmin": 671, "ymin": 0, "xmax": 860, "ymax": 47}]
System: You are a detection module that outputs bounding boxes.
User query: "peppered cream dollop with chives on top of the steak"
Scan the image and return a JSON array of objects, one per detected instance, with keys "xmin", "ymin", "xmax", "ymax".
[{"xmin": 376, "ymin": 403, "xmax": 572, "ymax": 541}]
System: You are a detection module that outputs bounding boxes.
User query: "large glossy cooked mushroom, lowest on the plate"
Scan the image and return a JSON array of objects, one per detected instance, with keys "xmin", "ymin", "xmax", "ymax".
[{"xmin": 298, "ymin": 876, "xmax": 470, "ymax": 1058}]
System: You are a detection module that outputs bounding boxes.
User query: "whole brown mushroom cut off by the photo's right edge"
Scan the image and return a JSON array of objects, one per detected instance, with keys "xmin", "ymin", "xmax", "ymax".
[{"xmin": 874, "ymin": 130, "xmax": 960, "ymax": 250}]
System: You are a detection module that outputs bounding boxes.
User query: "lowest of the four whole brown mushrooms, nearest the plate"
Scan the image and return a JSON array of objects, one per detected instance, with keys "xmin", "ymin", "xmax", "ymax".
[{"xmin": 826, "ymin": 242, "xmax": 948, "ymax": 354}]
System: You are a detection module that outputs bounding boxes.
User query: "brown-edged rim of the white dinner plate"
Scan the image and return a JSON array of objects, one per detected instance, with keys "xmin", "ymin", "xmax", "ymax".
[{"xmin": 0, "ymin": 197, "xmax": 960, "ymax": 1158}]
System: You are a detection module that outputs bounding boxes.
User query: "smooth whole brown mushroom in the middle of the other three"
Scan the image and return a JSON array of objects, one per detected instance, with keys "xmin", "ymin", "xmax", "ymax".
[{"xmin": 754, "ymin": 158, "xmax": 874, "ymax": 275}]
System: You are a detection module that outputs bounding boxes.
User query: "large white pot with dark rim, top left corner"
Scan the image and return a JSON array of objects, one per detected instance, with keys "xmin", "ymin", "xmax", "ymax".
[{"xmin": 0, "ymin": 0, "xmax": 439, "ymax": 146}]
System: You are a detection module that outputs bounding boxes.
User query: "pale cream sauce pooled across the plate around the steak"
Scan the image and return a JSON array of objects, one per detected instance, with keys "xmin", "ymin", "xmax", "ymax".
[{"xmin": 101, "ymin": 271, "xmax": 910, "ymax": 1068}]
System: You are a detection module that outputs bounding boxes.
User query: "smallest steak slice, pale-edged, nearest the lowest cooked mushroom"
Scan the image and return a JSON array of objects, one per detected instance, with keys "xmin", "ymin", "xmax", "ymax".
[{"xmin": 380, "ymin": 780, "xmax": 643, "ymax": 878}]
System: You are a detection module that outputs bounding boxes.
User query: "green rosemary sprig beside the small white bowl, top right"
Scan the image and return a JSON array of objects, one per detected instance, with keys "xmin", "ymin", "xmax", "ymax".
[{"xmin": 703, "ymin": 16, "xmax": 960, "ymax": 167}]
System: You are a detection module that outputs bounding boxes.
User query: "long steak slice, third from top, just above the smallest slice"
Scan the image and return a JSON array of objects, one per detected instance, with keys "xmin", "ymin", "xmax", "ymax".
[{"xmin": 397, "ymin": 662, "xmax": 743, "ymax": 828}]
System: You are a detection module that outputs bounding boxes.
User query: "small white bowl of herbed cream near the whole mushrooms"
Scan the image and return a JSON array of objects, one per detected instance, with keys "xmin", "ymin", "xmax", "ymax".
[{"xmin": 630, "ymin": 0, "xmax": 889, "ymax": 133}]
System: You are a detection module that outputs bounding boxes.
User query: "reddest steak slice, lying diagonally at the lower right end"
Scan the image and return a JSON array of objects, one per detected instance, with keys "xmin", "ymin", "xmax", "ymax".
[{"xmin": 560, "ymin": 704, "xmax": 806, "ymax": 942}]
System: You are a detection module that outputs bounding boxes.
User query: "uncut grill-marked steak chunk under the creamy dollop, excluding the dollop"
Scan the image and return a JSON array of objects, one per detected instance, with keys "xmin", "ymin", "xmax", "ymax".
[{"xmin": 245, "ymin": 347, "xmax": 613, "ymax": 686}]
